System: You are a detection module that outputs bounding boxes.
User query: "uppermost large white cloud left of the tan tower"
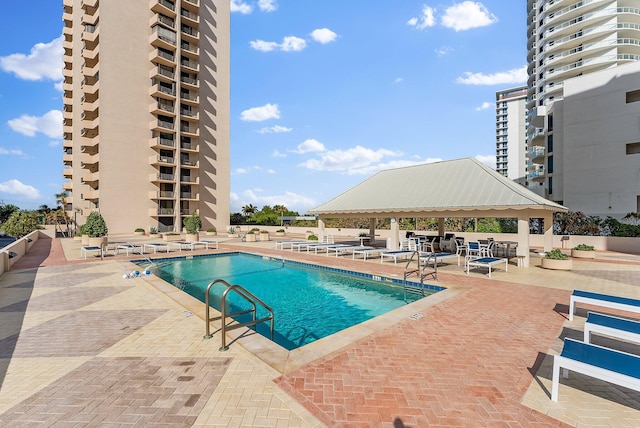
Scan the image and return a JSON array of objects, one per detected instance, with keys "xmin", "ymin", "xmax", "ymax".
[{"xmin": 0, "ymin": 36, "xmax": 64, "ymax": 82}]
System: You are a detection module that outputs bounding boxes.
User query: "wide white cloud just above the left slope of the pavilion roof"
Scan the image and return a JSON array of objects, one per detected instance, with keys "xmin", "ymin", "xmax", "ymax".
[{"xmin": 298, "ymin": 146, "xmax": 402, "ymax": 174}]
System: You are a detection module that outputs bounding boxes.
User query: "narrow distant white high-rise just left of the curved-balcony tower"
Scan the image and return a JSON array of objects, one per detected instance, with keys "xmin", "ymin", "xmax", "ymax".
[{"xmin": 496, "ymin": 86, "xmax": 527, "ymax": 185}]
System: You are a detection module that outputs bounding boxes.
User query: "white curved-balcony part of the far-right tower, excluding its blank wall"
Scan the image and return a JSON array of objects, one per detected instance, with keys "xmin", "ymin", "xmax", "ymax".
[{"xmin": 527, "ymin": 0, "xmax": 640, "ymax": 201}]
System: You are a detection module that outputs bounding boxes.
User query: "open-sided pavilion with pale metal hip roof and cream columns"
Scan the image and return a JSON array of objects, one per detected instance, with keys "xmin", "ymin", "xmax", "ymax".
[{"xmin": 309, "ymin": 158, "xmax": 568, "ymax": 266}]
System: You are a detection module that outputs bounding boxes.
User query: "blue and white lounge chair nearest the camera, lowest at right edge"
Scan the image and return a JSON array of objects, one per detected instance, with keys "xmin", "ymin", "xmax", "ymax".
[{"xmin": 551, "ymin": 338, "xmax": 640, "ymax": 401}]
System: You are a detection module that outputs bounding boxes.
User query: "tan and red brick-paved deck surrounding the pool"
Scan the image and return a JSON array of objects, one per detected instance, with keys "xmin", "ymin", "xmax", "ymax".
[{"xmin": 0, "ymin": 237, "xmax": 640, "ymax": 427}]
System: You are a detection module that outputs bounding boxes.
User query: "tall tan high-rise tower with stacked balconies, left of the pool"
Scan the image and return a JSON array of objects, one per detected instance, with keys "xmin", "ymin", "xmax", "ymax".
[{"xmin": 62, "ymin": 0, "xmax": 230, "ymax": 233}]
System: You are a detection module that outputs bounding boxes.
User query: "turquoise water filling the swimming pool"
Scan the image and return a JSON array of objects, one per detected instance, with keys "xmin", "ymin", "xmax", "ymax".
[{"xmin": 141, "ymin": 253, "xmax": 439, "ymax": 350}]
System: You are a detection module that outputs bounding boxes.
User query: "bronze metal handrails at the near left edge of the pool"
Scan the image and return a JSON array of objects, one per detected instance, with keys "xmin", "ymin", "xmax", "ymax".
[{"xmin": 204, "ymin": 279, "xmax": 273, "ymax": 351}]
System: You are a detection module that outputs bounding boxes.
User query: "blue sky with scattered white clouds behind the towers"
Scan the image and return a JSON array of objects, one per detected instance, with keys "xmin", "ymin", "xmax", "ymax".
[{"xmin": 0, "ymin": 0, "xmax": 527, "ymax": 214}]
